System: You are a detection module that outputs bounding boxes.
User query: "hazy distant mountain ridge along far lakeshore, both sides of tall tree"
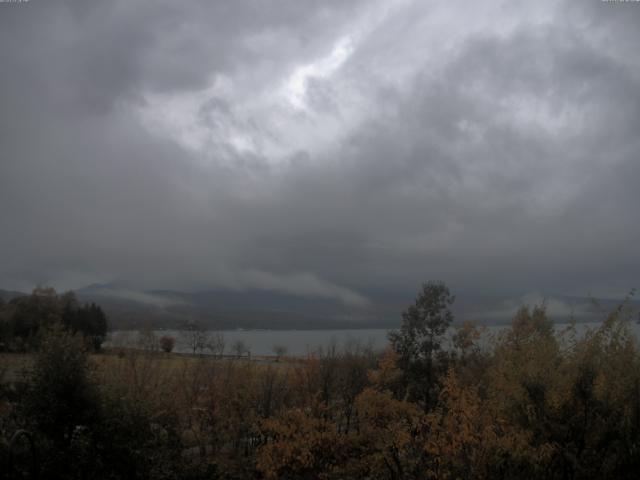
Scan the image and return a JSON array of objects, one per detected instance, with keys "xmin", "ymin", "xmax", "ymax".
[{"xmin": 0, "ymin": 284, "xmax": 640, "ymax": 330}]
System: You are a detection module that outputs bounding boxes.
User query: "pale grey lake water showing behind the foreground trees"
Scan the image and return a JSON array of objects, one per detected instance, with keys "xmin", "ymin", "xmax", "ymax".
[{"xmin": 105, "ymin": 323, "xmax": 640, "ymax": 356}]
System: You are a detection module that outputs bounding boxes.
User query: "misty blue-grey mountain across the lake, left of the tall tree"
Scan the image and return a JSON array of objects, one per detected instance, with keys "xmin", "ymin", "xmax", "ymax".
[{"xmin": 76, "ymin": 285, "xmax": 382, "ymax": 329}]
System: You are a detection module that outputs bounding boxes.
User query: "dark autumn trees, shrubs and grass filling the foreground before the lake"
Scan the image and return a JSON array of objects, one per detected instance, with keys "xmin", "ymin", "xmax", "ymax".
[{"xmin": 0, "ymin": 283, "xmax": 640, "ymax": 479}]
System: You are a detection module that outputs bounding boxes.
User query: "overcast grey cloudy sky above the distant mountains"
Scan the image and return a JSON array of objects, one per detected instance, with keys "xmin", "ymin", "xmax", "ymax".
[{"xmin": 0, "ymin": 0, "xmax": 640, "ymax": 305}]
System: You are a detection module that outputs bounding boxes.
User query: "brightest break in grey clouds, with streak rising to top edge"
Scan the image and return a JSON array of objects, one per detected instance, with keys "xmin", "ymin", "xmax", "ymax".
[{"xmin": 138, "ymin": 2, "xmax": 404, "ymax": 165}]
